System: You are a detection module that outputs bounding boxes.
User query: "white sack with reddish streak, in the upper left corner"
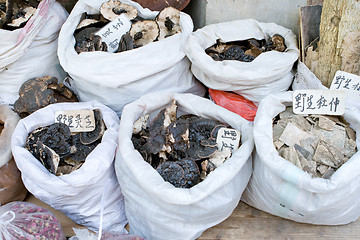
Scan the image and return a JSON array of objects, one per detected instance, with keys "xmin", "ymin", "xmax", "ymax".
[{"xmin": 0, "ymin": 0, "xmax": 68, "ymax": 104}]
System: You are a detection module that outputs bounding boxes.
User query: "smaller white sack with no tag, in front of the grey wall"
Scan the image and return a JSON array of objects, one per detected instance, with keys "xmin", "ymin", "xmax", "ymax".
[{"xmin": 185, "ymin": 19, "xmax": 299, "ymax": 102}]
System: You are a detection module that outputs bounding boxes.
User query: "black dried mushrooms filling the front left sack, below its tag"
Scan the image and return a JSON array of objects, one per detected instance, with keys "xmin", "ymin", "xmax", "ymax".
[{"xmin": 25, "ymin": 109, "xmax": 105, "ymax": 175}]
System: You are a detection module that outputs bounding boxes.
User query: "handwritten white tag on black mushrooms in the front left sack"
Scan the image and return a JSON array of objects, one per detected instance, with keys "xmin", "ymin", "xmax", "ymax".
[{"xmin": 55, "ymin": 110, "xmax": 95, "ymax": 132}]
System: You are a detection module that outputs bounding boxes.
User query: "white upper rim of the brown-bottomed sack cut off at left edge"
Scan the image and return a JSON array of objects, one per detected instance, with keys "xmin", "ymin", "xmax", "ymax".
[{"xmin": 0, "ymin": 105, "xmax": 20, "ymax": 167}]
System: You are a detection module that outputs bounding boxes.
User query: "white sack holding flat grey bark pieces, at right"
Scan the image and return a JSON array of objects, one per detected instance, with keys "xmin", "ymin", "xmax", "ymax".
[{"xmin": 243, "ymin": 92, "xmax": 360, "ymax": 225}]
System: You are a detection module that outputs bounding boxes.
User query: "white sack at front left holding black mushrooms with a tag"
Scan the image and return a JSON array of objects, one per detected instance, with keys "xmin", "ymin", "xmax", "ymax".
[{"xmin": 11, "ymin": 101, "xmax": 126, "ymax": 231}]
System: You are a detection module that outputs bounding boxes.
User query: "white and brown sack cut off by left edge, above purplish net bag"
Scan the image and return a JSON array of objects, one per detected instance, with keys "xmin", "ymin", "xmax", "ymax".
[{"xmin": 0, "ymin": 105, "xmax": 27, "ymax": 205}]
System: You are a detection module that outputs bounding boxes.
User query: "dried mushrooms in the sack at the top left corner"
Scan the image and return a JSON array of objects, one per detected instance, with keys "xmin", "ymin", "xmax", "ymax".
[{"xmin": 0, "ymin": 0, "xmax": 41, "ymax": 30}]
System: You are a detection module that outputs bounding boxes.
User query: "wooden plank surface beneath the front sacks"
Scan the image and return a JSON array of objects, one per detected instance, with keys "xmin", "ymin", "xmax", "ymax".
[{"xmin": 26, "ymin": 195, "xmax": 360, "ymax": 240}]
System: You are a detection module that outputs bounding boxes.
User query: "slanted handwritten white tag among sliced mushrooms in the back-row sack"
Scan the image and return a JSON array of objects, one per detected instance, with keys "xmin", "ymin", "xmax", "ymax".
[{"xmin": 96, "ymin": 14, "xmax": 131, "ymax": 52}]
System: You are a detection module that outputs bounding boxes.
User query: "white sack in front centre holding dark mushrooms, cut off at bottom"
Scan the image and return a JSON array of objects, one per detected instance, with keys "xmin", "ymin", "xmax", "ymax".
[{"xmin": 115, "ymin": 93, "xmax": 253, "ymax": 240}]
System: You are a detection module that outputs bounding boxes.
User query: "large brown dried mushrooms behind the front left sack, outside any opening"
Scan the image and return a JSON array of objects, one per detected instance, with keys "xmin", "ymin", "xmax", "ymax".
[{"xmin": 14, "ymin": 76, "xmax": 78, "ymax": 117}]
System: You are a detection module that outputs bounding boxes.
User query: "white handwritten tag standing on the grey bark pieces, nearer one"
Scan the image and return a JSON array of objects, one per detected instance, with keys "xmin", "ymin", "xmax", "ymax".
[{"xmin": 293, "ymin": 90, "xmax": 345, "ymax": 115}]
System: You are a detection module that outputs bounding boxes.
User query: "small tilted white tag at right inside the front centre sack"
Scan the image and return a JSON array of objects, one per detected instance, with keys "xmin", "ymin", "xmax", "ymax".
[{"xmin": 216, "ymin": 128, "xmax": 241, "ymax": 151}]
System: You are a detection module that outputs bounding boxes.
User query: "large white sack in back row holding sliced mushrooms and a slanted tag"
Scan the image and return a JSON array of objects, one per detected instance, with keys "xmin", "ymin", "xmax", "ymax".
[{"xmin": 58, "ymin": 0, "xmax": 204, "ymax": 114}]
